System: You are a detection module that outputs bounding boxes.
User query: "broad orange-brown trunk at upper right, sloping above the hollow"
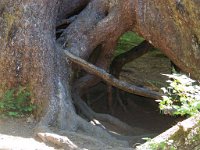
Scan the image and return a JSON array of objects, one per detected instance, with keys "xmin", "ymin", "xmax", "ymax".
[{"xmin": 134, "ymin": 0, "xmax": 200, "ymax": 79}]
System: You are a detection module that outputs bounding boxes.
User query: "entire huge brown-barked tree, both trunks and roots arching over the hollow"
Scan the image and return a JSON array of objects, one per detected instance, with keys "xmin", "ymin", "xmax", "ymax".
[{"xmin": 0, "ymin": 0, "xmax": 200, "ymax": 148}]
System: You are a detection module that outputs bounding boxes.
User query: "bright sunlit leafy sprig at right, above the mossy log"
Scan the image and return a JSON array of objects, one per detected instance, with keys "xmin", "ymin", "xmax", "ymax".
[{"xmin": 158, "ymin": 74, "xmax": 200, "ymax": 116}]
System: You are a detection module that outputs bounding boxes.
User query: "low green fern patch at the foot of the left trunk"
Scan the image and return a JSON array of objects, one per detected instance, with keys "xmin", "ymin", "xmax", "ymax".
[{"xmin": 0, "ymin": 86, "xmax": 36, "ymax": 117}]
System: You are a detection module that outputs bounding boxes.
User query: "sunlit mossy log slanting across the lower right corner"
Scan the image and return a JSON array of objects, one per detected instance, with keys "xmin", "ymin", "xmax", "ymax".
[{"xmin": 136, "ymin": 113, "xmax": 200, "ymax": 150}]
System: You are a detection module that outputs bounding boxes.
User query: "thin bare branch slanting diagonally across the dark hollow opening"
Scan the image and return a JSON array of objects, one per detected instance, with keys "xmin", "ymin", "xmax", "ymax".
[{"xmin": 64, "ymin": 50, "xmax": 161, "ymax": 99}]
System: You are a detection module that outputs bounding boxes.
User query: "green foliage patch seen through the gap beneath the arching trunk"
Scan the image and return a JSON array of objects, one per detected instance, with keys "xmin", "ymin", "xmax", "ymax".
[{"xmin": 115, "ymin": 32, "xmax": 144, "ymax": 56}]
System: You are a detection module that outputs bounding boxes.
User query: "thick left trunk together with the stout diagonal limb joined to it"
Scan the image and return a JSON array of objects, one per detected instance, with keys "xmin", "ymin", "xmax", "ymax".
[{"xmin": 0, "ymin": 0, "xmax": 136, "ymax": 148}]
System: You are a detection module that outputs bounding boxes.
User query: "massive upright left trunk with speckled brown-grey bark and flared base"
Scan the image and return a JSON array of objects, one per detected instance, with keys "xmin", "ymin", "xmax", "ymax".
[{"xmin": 0, "ymin": 0, "xmax": 76, "ymax": 129}]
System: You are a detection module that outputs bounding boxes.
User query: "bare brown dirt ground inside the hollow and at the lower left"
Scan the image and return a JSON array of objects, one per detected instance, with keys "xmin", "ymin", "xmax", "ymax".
[{"xmin": 0, "ymin": 50, "xmax": 182, "ymax": 150}]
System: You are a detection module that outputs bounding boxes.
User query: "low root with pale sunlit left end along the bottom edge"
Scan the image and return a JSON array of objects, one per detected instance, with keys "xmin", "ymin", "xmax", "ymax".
[{"xmin": 38, "ymin": 128, "xmax": 129, "ymax": 150}]
